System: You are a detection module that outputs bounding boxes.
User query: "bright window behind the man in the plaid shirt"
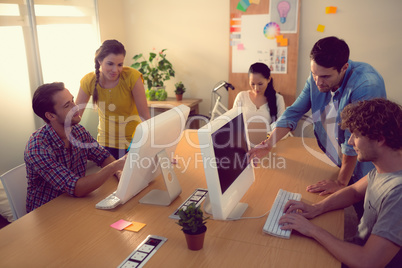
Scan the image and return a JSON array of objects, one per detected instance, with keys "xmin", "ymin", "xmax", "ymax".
[{"xmin": 0, "ymin": 0, "xmax": 100, "ymax": 174}]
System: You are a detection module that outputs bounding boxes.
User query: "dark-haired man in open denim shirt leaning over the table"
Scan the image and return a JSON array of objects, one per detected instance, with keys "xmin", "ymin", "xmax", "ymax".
[{"xmin": 249, "ymin": 37, "xmax": 386, "ymax": 200}]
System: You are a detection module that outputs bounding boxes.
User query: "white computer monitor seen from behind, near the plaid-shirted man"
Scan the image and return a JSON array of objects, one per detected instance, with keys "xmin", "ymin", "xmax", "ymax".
[{"xmin": 115, "ymin": 105, "xmax": 190, "ymax": 206}]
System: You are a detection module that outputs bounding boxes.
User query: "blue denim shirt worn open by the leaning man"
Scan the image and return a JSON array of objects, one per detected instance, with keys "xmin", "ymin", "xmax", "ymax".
[{"xmin": 275, "ymin": 60, "xmax": 386, "ymax": 181}]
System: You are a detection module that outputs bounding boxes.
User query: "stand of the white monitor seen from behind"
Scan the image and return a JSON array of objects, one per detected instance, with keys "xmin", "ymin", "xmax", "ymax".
[{"xmin": 140, "ymin": 150, "xmax": 181, "ymax": 206}]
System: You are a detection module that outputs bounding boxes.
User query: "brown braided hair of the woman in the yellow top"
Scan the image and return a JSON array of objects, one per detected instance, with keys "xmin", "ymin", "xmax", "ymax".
[{"xmin": 92, "ymin": 40, "xmax": 126, "ymax": 105}]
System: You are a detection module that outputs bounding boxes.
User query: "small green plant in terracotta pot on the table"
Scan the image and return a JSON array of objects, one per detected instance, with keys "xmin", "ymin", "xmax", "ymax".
[{"xmin": 176, "ymin": 203, "xmax": 209, "ymax": 250}]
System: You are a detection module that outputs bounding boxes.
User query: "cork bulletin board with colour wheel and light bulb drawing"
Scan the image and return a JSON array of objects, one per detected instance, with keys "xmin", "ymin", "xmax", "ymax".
[{"xmin": 228, "ymin": 0, "xmax": 301, "ymax": 108}]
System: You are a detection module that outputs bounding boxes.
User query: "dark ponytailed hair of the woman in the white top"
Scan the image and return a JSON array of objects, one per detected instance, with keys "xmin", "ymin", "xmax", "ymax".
[{"xmin": 248, "ymin": 62, "xmax": 278, "ymax": 122}]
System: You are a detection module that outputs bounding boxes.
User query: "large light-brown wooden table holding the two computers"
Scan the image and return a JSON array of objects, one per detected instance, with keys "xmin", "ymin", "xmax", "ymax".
[{"xmin": 0, "ymin": 130, "xmax": 344, "ymax": 267}]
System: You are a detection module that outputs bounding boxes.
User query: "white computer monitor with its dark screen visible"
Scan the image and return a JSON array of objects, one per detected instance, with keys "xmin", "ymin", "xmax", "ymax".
[{"xmin": 198, "ymin": 108, "xmax": 254, "ymax": 220}]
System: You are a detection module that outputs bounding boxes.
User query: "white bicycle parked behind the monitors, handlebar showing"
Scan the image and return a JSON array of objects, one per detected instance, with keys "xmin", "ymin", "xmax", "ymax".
[{"xmin": 186, "ymin": 81, "xmax": 235, "ymax": 129}]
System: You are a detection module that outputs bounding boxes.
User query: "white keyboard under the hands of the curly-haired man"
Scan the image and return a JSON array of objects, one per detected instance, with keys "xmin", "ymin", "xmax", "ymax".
[{"xmin": 262, "ymin": 189, "xmax": 301, "ymax": 239}]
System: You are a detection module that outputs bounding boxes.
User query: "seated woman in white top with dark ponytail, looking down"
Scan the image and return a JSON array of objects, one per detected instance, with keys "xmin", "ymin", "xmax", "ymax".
[{"xmin": 233, "ymin": 62, "xmax": 285, "ymax": 144}]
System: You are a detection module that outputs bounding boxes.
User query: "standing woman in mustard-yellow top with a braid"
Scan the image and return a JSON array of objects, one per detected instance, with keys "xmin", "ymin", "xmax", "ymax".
[{"xmin": 76, "ymin": 40, "xmax": 150, "ymax": 159}]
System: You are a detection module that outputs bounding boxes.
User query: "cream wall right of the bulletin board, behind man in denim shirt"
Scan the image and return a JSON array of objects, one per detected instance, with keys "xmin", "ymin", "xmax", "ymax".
[{"xmin": 297, "ymin": 0, "xmax": 402, "ymax": 104}]
